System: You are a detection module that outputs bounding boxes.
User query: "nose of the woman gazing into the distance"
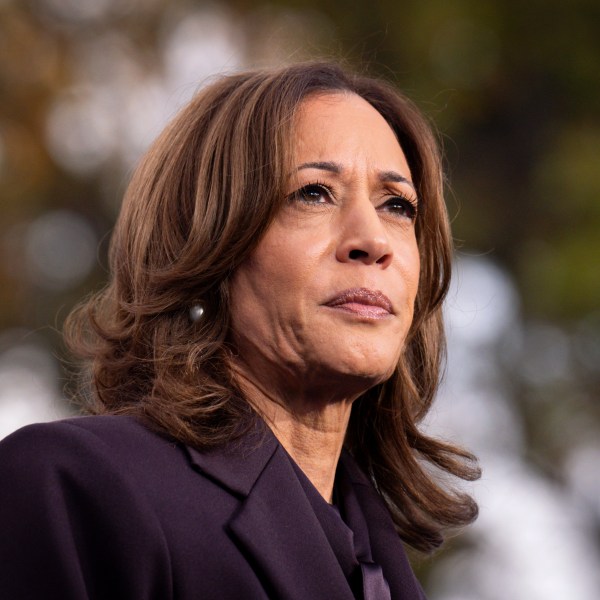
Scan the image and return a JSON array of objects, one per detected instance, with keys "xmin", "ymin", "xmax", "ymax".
[{"xmin": 336, "ymin": 200, "xmax": 393, "ymax": 268}]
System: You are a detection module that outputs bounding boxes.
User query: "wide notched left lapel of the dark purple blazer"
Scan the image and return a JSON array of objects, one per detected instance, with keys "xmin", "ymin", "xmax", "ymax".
[{"xmin": 188, "ymin": 427, "xmax": 354, "ymax": 600}]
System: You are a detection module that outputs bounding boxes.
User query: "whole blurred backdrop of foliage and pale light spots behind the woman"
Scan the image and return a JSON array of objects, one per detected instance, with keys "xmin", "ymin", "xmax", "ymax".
[{"xmin": 0, "ymin": 0, "xmax": 600, "ymax": 600}]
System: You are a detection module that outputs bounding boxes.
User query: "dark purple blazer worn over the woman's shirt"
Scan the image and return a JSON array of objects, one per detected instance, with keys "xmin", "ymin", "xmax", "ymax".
[{"xmin": 0, "ymin": 416, "xmax": 424, "ymax": 600}]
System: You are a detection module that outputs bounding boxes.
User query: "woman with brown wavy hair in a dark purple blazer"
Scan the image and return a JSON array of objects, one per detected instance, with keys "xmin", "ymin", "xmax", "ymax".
[{"xmin": 0, "ymin": 64, "xmax": 477, "ymax": 599}]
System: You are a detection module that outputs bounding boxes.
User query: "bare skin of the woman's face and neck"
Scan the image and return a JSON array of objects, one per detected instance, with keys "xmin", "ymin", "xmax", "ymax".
[{"xmin": 230, "ymin": 93, "xmax": 419, "ymax": 502}]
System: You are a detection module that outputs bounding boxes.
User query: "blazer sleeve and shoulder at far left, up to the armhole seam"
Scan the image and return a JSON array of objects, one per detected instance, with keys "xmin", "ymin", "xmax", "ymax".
[{"xmin": 0, "ymin": 416, "xmax": 180, "ymax": 598}]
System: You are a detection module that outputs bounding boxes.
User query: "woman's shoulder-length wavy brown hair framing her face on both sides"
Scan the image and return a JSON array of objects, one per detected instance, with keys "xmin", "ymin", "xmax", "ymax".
[{"xmin": 65, "ymin": 63, "xmax": 478, "ymax": 551}]
